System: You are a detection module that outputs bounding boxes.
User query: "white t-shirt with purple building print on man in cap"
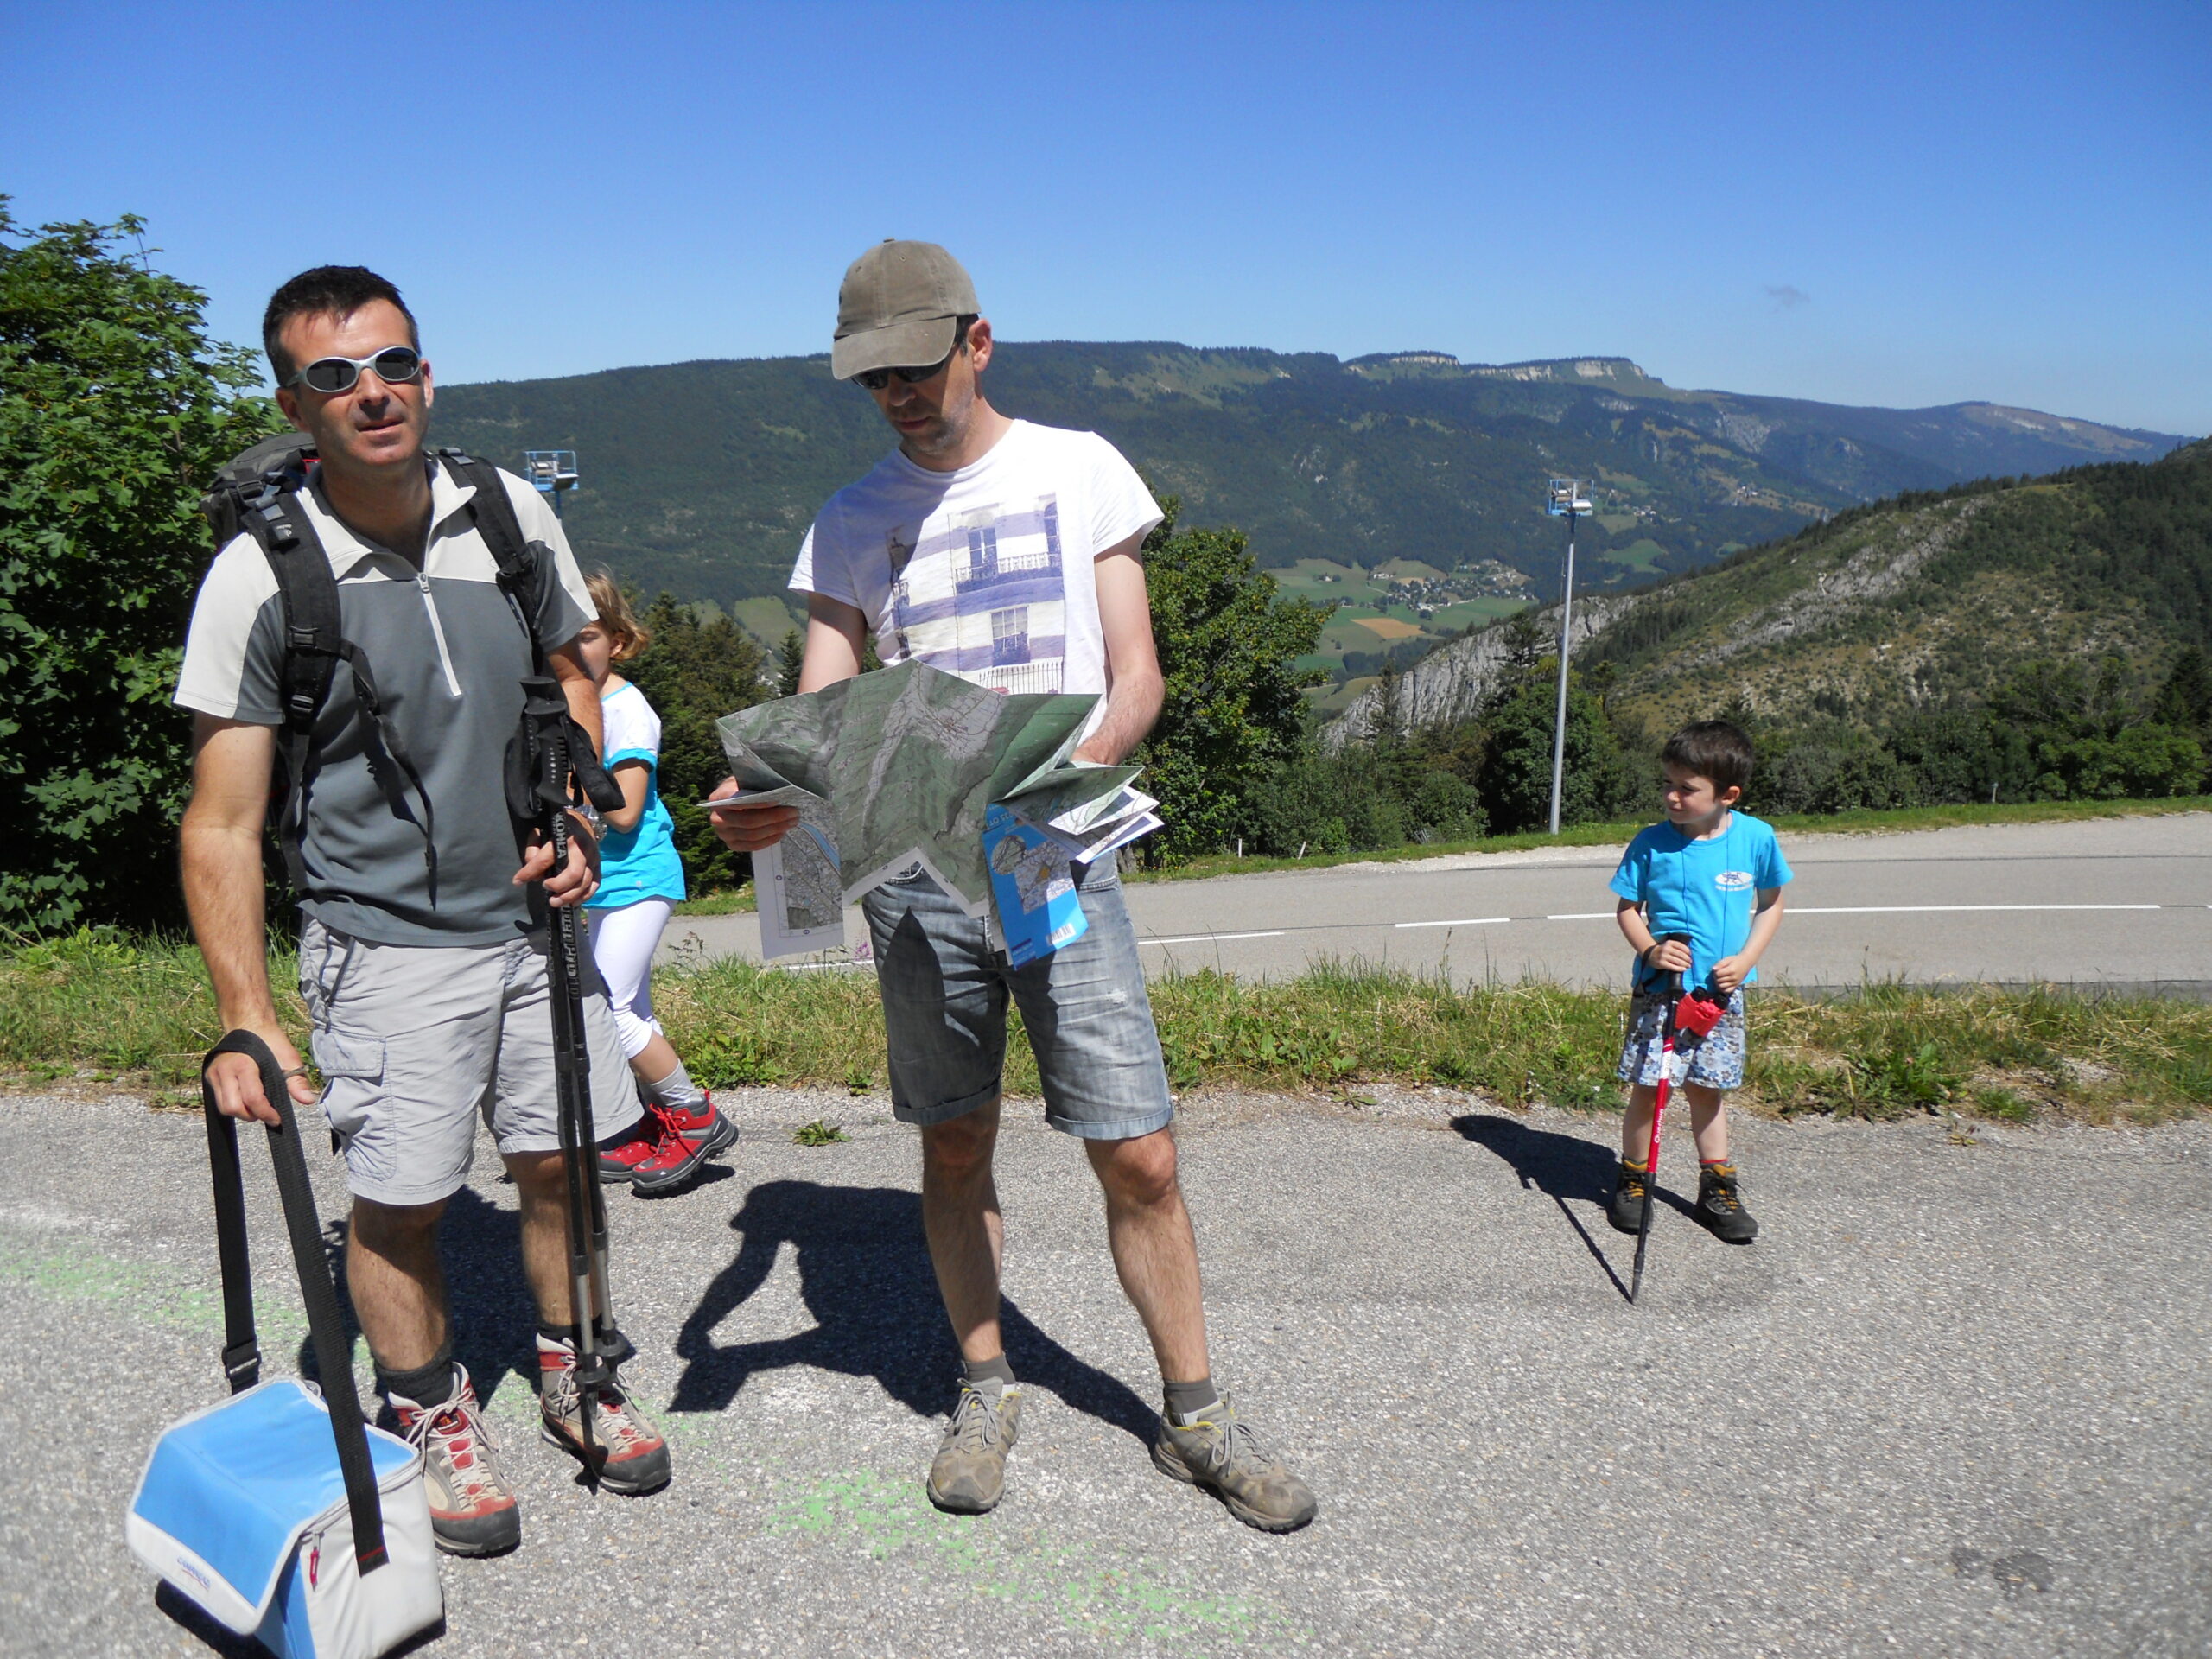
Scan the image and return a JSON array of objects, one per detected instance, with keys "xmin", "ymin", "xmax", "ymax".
[{"xmin": 791, "ymin": 420, "xmax": 1161, "ymax": 726}]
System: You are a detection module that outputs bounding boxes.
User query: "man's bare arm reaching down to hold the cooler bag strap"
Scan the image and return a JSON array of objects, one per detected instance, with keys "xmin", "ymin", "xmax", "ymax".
[{"xmin": 179, "ymin": 715, "xmax": 315, "ymax": 1123}]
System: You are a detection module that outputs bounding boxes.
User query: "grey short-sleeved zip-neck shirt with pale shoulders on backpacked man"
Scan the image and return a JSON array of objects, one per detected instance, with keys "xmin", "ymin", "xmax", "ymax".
[{"xmin": 177, "ymin": 460, "xmax": 595, "ymax": 944}]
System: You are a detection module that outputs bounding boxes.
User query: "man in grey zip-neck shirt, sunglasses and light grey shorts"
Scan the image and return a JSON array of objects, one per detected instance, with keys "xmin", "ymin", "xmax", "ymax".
[{"xmin": 177, "ymin": 265, "xmax": 668, "ymax": 1555}]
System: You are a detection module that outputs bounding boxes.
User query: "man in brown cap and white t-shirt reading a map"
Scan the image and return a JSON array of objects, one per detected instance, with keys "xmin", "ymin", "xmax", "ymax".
[{"xmin": 715, "ymin": 241, "xmax": 1314, "ymax": 1533}]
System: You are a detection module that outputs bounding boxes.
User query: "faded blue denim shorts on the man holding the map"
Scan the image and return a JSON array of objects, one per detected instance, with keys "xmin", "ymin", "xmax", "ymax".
[{"xmin": 861, "ymin": 861, "xmax": 1174, "ymax": 1141}]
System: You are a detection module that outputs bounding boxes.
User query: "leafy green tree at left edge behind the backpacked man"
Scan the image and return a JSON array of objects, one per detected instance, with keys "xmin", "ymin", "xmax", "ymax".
[{"xmin": 0, "ymin": 197, "xmax": 281, "ymax": 929}]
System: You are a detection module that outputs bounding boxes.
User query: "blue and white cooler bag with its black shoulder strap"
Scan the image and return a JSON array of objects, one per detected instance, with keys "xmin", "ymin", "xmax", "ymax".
[{"xmin": 124, "ymin": 1031, "xmax": 445, "ymax": 1659}]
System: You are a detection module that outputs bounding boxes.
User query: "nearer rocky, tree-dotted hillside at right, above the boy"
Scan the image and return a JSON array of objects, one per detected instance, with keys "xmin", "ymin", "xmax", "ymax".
[{"xmin": 1325, "ymin": 442, "xmax": 2212, "ymax": 831}]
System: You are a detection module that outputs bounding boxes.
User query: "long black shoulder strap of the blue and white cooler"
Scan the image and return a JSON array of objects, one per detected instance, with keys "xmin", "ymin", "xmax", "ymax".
[{"xmin": 199, "ymin": 1031, "xmax": 390, "ymax": 1573}]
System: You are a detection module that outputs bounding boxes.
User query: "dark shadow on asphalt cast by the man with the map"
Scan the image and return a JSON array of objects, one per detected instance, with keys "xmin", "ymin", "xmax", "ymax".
[{"xmin": 668, "ymin": 1181, "xmax": 1157, "ymax": 1442}]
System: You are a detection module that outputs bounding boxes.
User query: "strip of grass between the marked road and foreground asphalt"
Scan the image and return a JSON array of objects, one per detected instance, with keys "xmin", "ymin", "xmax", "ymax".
[{"xmin": 13, "ymin": 931, "xmax": 2212, "ymax": 1122}]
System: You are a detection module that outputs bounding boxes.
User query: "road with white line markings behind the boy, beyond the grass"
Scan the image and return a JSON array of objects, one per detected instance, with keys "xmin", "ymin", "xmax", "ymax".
[{"xmin": 664, "ymin": 814, "xmax": 2212, "ymax": 995}]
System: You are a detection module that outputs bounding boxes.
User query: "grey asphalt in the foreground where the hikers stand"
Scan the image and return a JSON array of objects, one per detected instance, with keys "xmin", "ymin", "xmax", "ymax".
[{"xmin": 0, "ymin": 1090, "xmax": 2212, "ymax": 1659}]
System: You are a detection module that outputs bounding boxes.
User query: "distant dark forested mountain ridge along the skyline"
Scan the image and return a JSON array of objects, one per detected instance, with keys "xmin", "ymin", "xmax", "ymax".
[{"xmin": 438, "ymin": 343, "xmax": 2179, "ymax": 639}]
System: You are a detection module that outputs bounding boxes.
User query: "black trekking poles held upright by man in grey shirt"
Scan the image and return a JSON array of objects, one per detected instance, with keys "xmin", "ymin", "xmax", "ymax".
[{"xmin": 522, "ymin": 677, "xmax": 621, "ymax": 1478}]
